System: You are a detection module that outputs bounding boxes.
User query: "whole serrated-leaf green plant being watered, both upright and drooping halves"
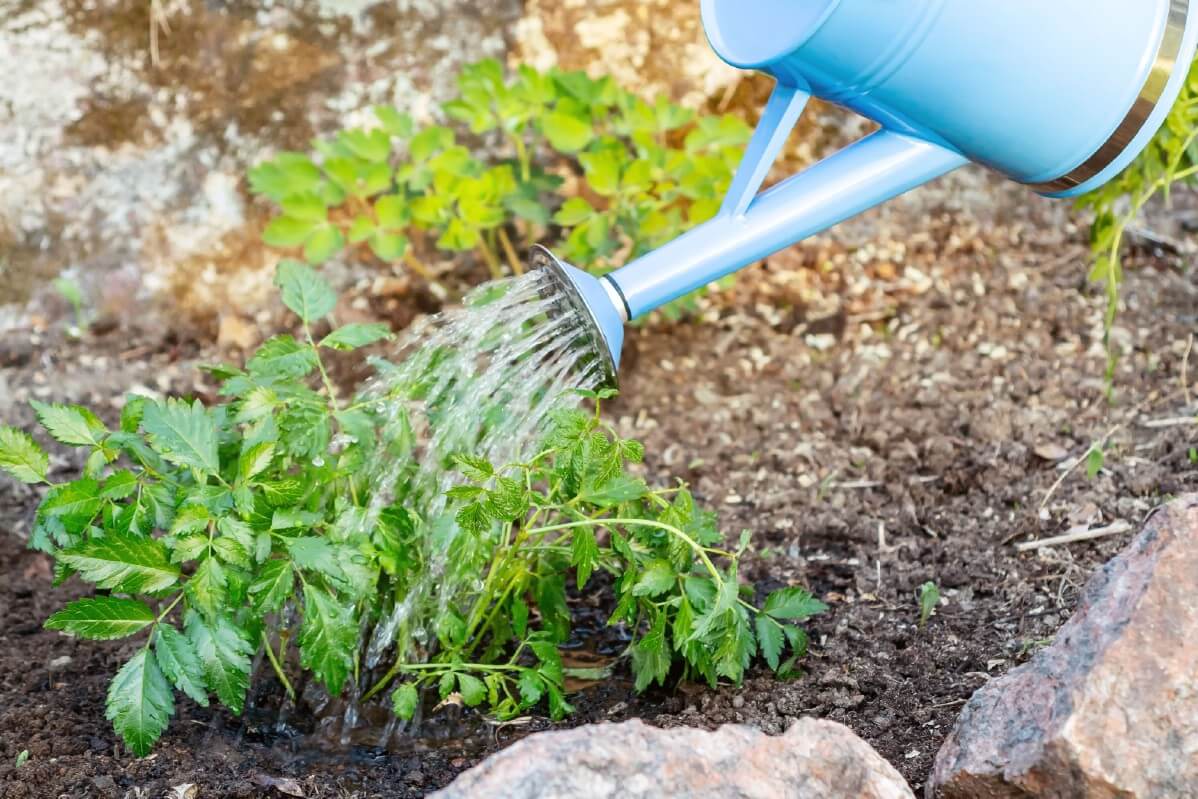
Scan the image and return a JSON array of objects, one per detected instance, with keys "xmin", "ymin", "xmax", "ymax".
[{"xmin": 0, "ymin": 261, "xmax": 824, "ymax": 755}]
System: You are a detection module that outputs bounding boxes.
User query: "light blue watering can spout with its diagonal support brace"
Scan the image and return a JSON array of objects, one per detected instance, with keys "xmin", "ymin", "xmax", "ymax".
[{"xmin": 603, "ymin": 83, "xmax": 968, "ymax": 320}]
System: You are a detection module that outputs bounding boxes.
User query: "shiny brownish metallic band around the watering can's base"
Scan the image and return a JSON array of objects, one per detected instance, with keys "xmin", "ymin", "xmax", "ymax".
[{"xmin": 1030, "ymin": 0, "xmax": 1191, "ymax": 194}]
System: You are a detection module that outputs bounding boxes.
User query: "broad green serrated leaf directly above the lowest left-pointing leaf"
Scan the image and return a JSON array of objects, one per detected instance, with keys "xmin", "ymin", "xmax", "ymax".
[{"xmin": 59, "ymin": 532, "xmax": 179, "ymax": 594}]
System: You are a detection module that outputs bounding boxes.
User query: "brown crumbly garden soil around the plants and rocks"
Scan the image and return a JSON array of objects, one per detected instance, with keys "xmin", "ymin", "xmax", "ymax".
[{"xmin": 0, "ymin": 176, "xmax": 1198, "ymax": 799}]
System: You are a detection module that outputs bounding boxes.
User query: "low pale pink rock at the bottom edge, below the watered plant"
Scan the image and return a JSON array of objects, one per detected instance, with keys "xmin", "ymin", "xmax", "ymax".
[{"xmin": 432, "ymin": 719, "xmax": 913, "ymax": 799}]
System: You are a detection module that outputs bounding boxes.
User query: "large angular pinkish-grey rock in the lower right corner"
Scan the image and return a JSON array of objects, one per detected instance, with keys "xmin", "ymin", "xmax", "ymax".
[{"xmin": 926, "ymin": 495, "xmax": 1198, "ymax": 799}]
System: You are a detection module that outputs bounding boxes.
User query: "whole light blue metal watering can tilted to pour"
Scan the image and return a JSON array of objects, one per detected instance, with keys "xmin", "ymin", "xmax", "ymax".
[{"xmin": 543, "ymin": 0, "xmax": 1198, "ymax": 383}]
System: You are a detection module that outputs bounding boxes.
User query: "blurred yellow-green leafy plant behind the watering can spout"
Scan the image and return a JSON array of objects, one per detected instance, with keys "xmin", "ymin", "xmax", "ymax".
[{"xmin": 249, "ymin": 60, "xmax": 751, "ymax": 313}]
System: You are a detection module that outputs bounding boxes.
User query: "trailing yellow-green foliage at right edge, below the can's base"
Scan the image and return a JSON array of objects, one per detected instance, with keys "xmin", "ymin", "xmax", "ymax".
[{"xmin": 1077, "ymin": 61, "xmax": 1198, "ymax": 394}]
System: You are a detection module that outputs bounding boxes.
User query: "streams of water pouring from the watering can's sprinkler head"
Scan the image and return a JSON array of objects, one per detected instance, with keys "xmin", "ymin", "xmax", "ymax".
[{"xmin": 343, "ymin": 271, "xmax": 604, "ymax": 694}]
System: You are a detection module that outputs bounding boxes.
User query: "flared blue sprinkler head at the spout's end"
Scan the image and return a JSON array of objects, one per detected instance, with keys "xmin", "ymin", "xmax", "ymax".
[{"xmin": 531, "ymin": 244, "xmax": 628, "ymax": 388}]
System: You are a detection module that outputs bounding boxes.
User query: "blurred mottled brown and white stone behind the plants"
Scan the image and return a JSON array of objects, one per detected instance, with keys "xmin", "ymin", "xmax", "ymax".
[{"xmin": 0, "ymin": 0, "xmax": 1035, "ymax": 346}]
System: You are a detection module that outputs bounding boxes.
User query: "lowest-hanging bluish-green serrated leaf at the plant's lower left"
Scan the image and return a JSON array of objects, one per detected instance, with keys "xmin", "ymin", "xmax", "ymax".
[{"xmin": 105, "ymin": 649, "xmax": 175, "ymax": 757}]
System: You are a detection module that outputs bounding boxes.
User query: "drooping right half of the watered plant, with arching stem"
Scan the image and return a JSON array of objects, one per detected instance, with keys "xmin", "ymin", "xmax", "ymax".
[{"xmin": 368, "ymin": 392, "xmax": 827, "ymax": 718}]
